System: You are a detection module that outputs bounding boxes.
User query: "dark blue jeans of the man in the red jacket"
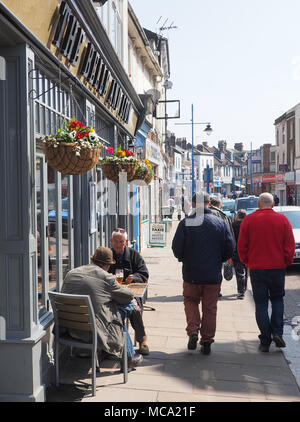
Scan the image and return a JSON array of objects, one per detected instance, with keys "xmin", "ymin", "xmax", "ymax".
[{"xmin": 250, "ymin": 269, "xmax": 285, "ymax": 346}]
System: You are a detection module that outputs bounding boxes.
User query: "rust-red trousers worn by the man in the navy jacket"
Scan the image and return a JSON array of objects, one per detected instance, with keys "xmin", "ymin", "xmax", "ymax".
[{"xmin": 183, "ymin": 282, "xmax": 220, "ymax": 344}]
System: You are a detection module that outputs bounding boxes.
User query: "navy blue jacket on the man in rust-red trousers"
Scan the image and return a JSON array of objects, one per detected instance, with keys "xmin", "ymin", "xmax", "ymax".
[{"xmin": 172, "ymin": 208, "xmax": 234, "ymax": 284}]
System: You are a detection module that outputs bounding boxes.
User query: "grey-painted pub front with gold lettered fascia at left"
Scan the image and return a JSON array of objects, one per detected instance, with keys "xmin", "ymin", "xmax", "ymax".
[{"xmin": 0, "ymin": 0, "xmax": 143, "ymax": 401}]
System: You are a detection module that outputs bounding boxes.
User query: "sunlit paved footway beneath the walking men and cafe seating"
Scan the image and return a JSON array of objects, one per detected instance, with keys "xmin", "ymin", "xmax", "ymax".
[{"xmin": 47, "ymin": 220, "xmax": 300, "ymax": 403}]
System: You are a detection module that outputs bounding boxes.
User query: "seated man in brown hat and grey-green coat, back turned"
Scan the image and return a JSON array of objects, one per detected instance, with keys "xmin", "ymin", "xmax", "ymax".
[{"xmin": 61, "ymin": 247, "xmax": 143, "ymax": 370}]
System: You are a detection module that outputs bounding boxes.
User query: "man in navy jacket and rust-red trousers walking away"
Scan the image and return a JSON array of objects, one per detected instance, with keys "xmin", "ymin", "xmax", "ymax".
[{"xmin": 172, "ymin": 192, "xmax": 234, "ymax": 355}]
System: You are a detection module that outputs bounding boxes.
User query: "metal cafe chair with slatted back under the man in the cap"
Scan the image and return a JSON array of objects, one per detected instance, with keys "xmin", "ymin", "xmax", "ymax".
[{"xmin": 49, "ymin": 292, "xmax": 128, "ymax": 396}]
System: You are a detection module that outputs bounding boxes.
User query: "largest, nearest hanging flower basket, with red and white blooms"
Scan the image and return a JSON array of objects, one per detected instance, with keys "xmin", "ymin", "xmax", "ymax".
[{"xmin": 42, "ymin": 119, "xmax": 103, "ymax": 175}]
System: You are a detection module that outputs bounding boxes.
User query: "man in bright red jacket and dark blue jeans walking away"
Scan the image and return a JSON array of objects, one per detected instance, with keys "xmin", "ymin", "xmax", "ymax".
[{"xmin": 237, "ymin": 193, "xmax": 295, "ymax": 352}]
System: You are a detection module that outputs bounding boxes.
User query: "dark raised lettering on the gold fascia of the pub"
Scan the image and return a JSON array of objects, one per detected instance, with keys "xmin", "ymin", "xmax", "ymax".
[{"xmin": 52, "ymin": 1, "xmax": 131, "ymax": 123}]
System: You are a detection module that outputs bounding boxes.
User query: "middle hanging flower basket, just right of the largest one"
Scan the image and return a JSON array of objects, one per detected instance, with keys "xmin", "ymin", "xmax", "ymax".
[{"xmin": 101, "ymin": 147, "xmax": 137, "ymax": 183}]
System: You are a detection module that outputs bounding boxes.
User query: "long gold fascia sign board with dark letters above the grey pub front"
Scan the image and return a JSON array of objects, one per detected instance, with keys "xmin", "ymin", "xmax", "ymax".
[{"xmin": 4, "ymin": 0, "xmax": 138, "ymax": 135}]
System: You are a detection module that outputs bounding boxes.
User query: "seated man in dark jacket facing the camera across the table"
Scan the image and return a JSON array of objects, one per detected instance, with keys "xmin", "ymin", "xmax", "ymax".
[{"xmin": 109, "ymin": 228, "xmax": 149, "ymax": 355}]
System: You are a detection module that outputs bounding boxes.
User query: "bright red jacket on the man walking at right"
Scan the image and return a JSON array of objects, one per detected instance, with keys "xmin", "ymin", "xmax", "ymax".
[{"xmin": 237, "ymin": 208, "xmax": 295, "ymax": 270}]
